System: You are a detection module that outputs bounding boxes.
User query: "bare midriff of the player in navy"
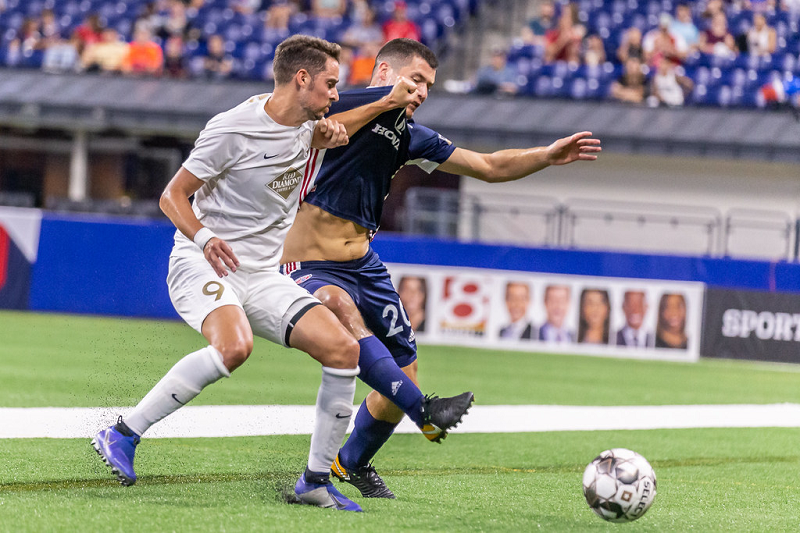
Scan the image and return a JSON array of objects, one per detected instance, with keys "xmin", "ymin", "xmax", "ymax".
[{"xmin": 281, "ymin": 203, "xmax": 369, "ymax": 264}]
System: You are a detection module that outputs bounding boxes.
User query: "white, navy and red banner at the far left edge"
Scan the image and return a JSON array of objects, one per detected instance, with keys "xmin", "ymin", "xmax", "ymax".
[{"xmin": 0, "ymin": 207, "xmax": 42, "ymax": 309}]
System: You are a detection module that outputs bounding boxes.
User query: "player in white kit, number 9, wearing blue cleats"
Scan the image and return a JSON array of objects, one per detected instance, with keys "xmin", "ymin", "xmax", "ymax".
[{"xmin": 92, "ymin": 35, "xmax": 415, "ymax": 511}]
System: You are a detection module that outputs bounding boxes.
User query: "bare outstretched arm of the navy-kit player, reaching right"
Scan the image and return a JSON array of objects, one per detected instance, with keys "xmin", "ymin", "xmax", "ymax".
[{"xmin": 439, "ymin": 131, "xmax": 602, "ymax": 183}]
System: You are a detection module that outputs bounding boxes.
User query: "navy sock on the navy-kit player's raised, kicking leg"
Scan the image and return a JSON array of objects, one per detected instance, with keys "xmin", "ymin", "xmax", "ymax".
[{"xmin": 358, "ymin": 335, "xmax": 425, "ymax": 427}]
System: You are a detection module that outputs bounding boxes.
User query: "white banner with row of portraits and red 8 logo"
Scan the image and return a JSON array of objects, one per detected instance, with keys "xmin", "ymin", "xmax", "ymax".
[{"xmin": 386, "ymin": 263, "xmax": 704, "ymax": 361}]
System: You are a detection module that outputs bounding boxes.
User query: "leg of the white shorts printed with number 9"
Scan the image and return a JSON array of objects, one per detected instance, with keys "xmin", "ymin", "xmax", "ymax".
[{"xmin": 167, "ymin": 256, "xmax": 247, "ymax": 335}]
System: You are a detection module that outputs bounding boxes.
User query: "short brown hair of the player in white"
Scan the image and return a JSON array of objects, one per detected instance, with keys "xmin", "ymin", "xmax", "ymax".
[{"xmin": 272, "ymin": 35, "xmax": 342, "ymax": 85}]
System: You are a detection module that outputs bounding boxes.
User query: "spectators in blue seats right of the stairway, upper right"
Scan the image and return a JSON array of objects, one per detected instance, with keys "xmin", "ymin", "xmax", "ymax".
[{"xmin": 473, "ymin": 0, "xmax": 800, "ymax": 106}]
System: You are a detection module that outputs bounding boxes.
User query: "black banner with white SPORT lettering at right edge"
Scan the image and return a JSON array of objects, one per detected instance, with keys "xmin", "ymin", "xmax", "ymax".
[{"xmin": 702, "ymin": 289, "xmax": 800, "ymax": 363}]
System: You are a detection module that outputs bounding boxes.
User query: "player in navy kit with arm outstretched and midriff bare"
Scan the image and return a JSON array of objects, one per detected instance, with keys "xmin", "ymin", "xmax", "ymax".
[{"xmin": 281, "ymin": 39, "xmax": 600, "ymax": 498}]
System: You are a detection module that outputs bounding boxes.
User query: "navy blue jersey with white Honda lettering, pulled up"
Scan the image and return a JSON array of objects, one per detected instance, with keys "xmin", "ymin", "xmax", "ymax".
[{"xmin": 301, "ymin": 87, "xmax": 455, "ymax": 231}]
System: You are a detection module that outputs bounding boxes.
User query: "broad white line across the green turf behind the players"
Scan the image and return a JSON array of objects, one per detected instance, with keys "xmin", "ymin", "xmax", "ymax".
[{"xmin": 0, "ymin": 403, "xmax": 800, "ymax": 439}]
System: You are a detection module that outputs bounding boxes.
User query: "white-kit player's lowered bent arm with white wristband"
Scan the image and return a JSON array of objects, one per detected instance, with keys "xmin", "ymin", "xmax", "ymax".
[{"xmin": 158, "ymin": 167, "xmax": 239, "ymax": 277}]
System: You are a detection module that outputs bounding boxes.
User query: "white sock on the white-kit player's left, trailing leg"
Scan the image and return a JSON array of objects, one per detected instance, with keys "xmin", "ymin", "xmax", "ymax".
[{"xmin": 125, "ymin": 346, "xmax": 231, "ymax": 435}]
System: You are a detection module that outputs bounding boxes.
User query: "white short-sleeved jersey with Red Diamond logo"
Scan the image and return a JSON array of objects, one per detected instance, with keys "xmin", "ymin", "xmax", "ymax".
[{"xmin": 172, "ymin": 94, "xmax": 316, "ymax": 272}]
